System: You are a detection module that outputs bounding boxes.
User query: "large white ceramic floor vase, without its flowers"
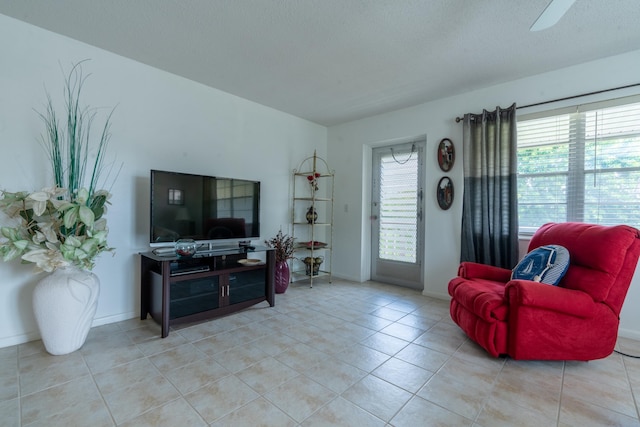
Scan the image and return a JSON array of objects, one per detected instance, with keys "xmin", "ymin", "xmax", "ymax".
[{"xmin": 33, "ymin": 266, "xmax": 100, "ymax": 355}]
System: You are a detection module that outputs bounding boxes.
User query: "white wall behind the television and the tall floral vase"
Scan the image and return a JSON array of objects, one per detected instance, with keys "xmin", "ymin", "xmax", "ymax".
[{"xmin": 0, "ymin": 15, "xmax": 327, "ymax": 347}]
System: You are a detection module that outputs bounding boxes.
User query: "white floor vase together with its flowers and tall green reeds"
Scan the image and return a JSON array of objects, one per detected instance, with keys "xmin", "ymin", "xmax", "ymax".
[{"xmin": 0, "ymin": 63, "xmax": 113, "ymax": 355}]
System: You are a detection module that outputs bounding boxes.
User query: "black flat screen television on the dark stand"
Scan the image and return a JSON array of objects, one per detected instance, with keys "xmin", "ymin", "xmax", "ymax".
[{"xmin": 150, "ymin": 170, "xmax": 260, "ymax": 247}]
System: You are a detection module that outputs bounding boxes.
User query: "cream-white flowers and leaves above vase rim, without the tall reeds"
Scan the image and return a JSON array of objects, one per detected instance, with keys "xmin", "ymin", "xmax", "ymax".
[{"xmin": 0, "ymin": 187, "xmax": 112, "ymax": 272}]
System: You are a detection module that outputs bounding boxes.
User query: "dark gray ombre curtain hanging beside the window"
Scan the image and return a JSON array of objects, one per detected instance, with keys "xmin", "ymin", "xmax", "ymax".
[{"xmin": 460, "ymin": 104, "xmax": 518, "ymax": 269}]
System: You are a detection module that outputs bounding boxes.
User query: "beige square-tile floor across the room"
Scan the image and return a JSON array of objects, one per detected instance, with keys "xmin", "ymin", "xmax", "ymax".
[{"xmin": 0, "ymin": 281, "xmax": 640, "ymax": 427}]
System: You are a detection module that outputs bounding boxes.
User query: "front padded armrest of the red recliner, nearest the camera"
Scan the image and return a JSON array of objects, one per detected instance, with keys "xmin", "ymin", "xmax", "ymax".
[{"xmin": 505, "ymin": 280, "xmax": 597, "ymax": 318}]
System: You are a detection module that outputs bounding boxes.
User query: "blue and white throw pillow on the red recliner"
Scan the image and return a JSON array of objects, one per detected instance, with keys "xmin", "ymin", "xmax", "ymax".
[{"xmin": 511, "ymin": 245, "xmax": 569, "ymax": 286}]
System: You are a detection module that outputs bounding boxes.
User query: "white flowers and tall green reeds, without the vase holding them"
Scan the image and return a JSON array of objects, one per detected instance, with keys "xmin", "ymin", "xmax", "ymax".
[{"xmin": 0, "ymin": 61, "xmax": 113, "ymax": 272}]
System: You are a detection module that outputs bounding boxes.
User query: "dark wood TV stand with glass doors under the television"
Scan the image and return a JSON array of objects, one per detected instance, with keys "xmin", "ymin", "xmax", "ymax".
[{"xmin": 140, "ymin": 247, "xmax": 275, "ymax": 338}]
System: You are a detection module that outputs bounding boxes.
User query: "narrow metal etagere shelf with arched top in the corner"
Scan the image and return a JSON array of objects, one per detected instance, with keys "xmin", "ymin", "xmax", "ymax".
[{"xmin": 291, "ymin": 151, "xmax": 334, "ymax": 287}]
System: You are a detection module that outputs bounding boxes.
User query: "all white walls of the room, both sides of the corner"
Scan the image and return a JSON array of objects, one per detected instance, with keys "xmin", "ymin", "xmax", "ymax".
[{"xmin": 0, "ymin": 15, "xmax": 640, "ymax": 347}]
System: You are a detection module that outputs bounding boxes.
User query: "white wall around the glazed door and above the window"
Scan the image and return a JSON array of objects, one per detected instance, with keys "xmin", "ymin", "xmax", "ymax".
[{"xmin": 328, "ymin": 47, "xmax": 640, "ymax": 339}]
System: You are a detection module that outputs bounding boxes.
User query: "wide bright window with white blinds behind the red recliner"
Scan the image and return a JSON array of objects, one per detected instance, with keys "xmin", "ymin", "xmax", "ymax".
[{"xmin": 518, "ymin": 97, "xmax": 640, "ymax": 234}]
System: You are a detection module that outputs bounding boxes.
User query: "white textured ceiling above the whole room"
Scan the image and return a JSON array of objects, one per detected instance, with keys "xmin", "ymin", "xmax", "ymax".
[{"xmin": 0, "ymin": 0, "xmax": 640, "ymax": 126}]
